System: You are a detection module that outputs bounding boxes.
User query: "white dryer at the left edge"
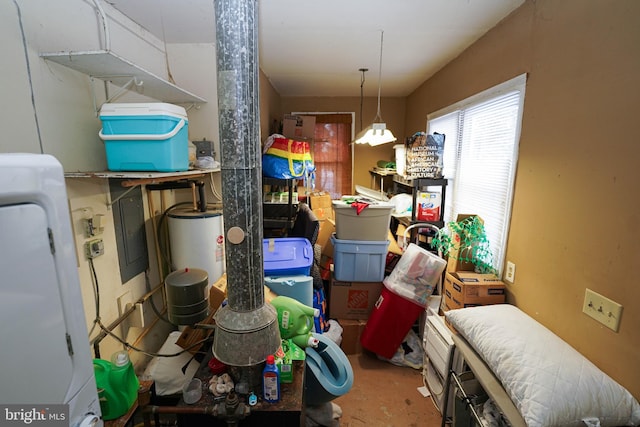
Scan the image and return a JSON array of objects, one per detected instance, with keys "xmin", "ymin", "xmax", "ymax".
[{"xmin": 0, "ymin": 154, "xmax": 103, "ymax": 427}]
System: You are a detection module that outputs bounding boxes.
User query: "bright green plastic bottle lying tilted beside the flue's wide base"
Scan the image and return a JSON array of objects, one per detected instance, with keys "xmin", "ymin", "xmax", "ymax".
[{"xmin": 271, "ymin": 295, "xmax": 320, "ymax": 348}]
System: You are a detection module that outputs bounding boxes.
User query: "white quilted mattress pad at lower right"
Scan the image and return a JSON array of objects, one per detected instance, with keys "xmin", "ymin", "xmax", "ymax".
[{"xmin": 445, "ymin": 304, "xmax": 640, "ymax": 427}]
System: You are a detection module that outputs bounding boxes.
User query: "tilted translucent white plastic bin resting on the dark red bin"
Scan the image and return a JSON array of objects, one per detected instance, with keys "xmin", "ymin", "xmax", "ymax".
[{"xmin": 384, "ymin": 243, "xmax": 447, "ymax": 307}]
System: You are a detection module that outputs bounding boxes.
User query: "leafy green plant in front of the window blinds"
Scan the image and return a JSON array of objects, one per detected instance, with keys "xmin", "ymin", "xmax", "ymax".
[{"xmin": 432, "ymin": 215, "xmax": 496, "ymax": 273}]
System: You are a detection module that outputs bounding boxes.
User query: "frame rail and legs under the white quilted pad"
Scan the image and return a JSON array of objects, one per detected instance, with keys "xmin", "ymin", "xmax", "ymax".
[{"xmin": 442, "ymin": 334, "xmax": 527, "ymax": 427}]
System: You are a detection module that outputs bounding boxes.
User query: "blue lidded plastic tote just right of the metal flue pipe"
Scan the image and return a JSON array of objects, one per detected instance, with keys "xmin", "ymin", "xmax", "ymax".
[{"xmin": 262, "ymin": 237, "xmax": 313, "ymax": 276}]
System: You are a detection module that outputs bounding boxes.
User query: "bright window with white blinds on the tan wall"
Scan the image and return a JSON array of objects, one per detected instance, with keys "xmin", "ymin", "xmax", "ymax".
[{"xmin": 427, "ymin": 75, "xmax": 526, "ymax": 272}]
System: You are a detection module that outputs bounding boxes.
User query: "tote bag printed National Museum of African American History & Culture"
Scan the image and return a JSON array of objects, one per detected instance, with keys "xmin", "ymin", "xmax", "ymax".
[{"xmin": 405, "ymin": 132, "xmax": 445, "ymax": 179}]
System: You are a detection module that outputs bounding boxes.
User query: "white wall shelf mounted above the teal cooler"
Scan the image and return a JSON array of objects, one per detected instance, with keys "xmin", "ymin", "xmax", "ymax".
[{"xmin": 40, "ymin": 50, "xmax": 207, "ymax": 104}]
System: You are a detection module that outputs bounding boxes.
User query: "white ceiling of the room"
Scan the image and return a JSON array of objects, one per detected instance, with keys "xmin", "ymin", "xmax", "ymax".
[{"xmin": 107, "ymin": 0, "xmax": 525, "ymax": 96}]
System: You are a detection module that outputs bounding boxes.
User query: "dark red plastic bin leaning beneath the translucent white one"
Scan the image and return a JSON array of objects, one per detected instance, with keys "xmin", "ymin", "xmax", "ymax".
[{"xmin": 360, "ymin": 285, "xmax": 424, "ymax": 359}]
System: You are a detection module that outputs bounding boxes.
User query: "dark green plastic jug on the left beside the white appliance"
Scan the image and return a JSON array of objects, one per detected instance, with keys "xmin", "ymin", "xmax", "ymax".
[{"xmin": 93, "ymin": 351, "xmax": 140, "ymax": 421}]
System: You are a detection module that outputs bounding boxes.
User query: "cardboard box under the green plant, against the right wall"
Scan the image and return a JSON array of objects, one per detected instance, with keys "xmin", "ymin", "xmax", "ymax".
[{"xmin": 444, "ymin": 271, "xmax": 506, "ymax": 310}]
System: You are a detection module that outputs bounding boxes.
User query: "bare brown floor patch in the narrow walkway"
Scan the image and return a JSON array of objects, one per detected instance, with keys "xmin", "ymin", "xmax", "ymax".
[{"xmin": 333, "ymin": 353, "xmax": 442, "ymax": 427}]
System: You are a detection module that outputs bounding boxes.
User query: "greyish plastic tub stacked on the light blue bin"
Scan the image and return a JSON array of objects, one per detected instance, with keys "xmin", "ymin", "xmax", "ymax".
[{"xmin": 332, "ymin": 199, "xmax": 394, "ymax": 241}]
